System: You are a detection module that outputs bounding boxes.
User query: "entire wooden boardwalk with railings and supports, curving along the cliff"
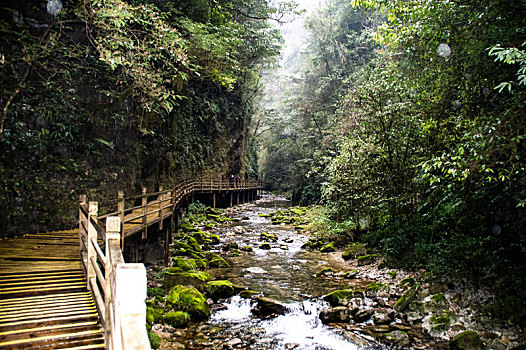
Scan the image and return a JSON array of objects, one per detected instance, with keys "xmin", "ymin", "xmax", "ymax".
[{"xmin": 0, "ymin": 179, "xmax": 262, "ymax": 350}]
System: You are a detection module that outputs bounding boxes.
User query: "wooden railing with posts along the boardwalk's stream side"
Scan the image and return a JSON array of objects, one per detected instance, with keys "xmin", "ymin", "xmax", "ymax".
[{"xmin": 79, "ymin": 178, "xmax": 262, "ymax": 350}]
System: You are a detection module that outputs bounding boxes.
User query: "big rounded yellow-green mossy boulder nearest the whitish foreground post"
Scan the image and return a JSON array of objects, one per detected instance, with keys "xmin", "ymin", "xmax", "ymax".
[{"xmin": 166, "ymin": 285, "xmax": 210, "ymax": 320}]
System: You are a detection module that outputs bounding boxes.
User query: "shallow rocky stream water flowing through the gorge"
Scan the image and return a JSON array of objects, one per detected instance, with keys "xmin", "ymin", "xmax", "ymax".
[{"xmin": 177, "ymin": 196, "xmax": 381, "ymax": 350}]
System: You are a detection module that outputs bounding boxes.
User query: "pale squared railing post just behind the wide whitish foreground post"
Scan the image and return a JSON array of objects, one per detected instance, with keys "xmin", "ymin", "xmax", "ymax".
[{"xmin": 104, "ymin": 216, "xmax": 121, "ymax": 349}]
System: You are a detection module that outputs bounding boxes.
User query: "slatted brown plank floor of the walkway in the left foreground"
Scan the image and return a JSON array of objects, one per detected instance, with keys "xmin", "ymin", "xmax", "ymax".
[{"xmin": 0, "ymin": 230, "xmax": 104, "ymax": 349}]
